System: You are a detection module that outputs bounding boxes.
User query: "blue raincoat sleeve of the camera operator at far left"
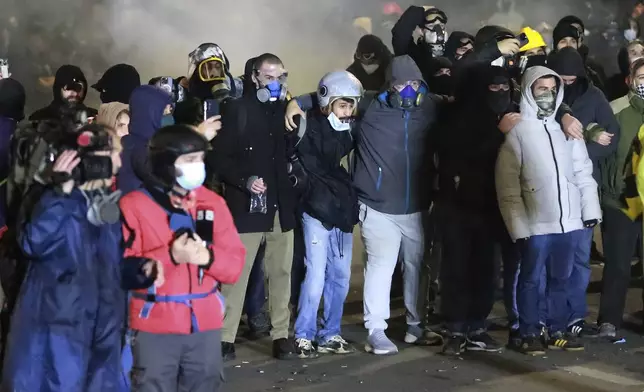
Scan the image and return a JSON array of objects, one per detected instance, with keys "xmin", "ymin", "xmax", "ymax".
[{"xmin": 18, "ymin": 190, "xmax": 78, "ymax": 260}]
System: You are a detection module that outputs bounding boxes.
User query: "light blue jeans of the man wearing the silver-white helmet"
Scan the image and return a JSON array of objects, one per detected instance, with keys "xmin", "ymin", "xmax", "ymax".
[{"xmin": 295, "ymin": 214, "xmax": 353, "ymax": 343}]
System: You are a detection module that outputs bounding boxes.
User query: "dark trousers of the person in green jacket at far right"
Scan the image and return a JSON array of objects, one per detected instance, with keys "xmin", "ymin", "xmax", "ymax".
[{"xmin": 598, "ymin": 207, "xmax": 642, "ymax": 328}]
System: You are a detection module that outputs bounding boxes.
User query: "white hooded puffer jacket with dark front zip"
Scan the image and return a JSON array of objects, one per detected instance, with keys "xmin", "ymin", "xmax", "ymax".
[{"xmin": 496, "ymin": 66, "xmax": 601, "ymax": 241}]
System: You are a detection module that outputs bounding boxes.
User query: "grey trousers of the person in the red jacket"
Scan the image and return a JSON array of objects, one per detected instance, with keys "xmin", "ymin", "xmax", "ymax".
[{"xmin": 131, "ymin": 330, "xmax": 224, "ymax": 392}]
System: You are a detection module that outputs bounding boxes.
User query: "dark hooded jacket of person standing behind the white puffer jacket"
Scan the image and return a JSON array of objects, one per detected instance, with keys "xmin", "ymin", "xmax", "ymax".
[{"xmin": 548, "ymin": 48, "xmax": 620, "ymax": 183}]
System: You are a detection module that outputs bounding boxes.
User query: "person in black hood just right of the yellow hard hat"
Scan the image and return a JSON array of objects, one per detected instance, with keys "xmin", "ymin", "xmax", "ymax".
[{"xmin": 552, "ymin": 16, "xmax": 606, "ymax": 91}]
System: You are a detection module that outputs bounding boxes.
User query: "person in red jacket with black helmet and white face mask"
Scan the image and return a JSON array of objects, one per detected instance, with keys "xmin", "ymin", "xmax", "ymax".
[{"xmin": 121, "ymin": 125, "xmax": 246, "ymax": 392}]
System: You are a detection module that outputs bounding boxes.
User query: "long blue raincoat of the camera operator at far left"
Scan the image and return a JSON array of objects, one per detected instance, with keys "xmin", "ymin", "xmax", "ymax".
[{"xmin": 2, "ymin": 189, "xmax": 150, "ymax": 392}]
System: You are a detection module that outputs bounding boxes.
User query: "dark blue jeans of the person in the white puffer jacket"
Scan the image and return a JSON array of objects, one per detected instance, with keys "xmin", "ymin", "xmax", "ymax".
[{"xmin": 517, "ymin": 230, "xmax": 583, "ymax": 336}]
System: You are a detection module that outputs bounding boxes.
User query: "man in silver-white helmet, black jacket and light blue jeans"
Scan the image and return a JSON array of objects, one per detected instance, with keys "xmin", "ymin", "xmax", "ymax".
[{"xmin": 295, "ymin": 71, "xmax": 363, "ymax": 358}]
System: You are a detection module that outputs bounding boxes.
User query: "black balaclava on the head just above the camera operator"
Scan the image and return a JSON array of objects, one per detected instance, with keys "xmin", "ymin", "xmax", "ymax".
[{"xmin": 92, "ymin": 64, "xmax": 141, "ymax": 105}]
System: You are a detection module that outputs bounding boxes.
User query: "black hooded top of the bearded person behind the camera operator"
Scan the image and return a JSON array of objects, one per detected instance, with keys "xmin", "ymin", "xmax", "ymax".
[{"xmin": 29, "ymin": 64, "xmax": 97, "ymax": 121}]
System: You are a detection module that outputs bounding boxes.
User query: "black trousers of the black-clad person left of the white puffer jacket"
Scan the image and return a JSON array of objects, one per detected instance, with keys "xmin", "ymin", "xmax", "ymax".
[{"xmin": 440, "ymin": 204, "xmax": 496, "ymax": 334}]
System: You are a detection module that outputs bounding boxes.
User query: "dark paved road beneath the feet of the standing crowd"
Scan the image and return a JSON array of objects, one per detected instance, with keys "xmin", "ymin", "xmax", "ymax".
[{"xmin": 225, "ymin": 231, "xmax": 644, "ymax": 392}]
